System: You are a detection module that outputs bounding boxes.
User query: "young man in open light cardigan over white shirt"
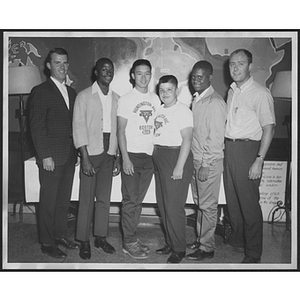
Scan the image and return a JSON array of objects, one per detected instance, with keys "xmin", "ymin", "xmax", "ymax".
[{"xmin": 73, "ymin": 58, "xmax": 121, "ymax": 259}]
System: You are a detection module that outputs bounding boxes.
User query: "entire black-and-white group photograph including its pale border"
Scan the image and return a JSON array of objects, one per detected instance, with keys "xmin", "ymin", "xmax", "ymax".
[{"xmin": 2, "ymin": 30, "xmax": 298, "ymax": 270}]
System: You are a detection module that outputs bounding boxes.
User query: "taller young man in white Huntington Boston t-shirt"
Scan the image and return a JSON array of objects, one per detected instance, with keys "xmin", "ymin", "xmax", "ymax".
[{"xmin": 117, "ymin": 59, "xmax": 160, "ymax": 259}]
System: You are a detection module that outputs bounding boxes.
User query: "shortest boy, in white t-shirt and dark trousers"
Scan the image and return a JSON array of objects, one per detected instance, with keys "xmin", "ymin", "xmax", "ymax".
[{"xmin": 153, "ymin": 75, "xmax": 193, "ymax": 263}]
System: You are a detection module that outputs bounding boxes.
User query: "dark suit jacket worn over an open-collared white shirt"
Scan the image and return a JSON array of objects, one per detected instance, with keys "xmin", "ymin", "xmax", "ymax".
[{"xmin": 28, "ymin": 79, "xmax": 76, "ymax": 166}]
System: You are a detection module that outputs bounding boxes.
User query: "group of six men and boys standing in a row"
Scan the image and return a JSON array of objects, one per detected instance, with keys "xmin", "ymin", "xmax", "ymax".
[{"xmin": 28, "ymin": 48, "xmax": 275, "ymax": 263}]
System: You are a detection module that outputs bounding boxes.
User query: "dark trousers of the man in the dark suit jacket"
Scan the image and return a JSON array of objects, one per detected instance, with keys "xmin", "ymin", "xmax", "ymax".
[{"xmin": 38, "ymin": 152, "xmax": 75, "ymax": 245}]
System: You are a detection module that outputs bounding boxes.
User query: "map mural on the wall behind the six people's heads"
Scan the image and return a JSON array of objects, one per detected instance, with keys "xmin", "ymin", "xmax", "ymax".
[{"xmin": 8, "ymin": 34, "xmax": 291, "ymax": 104}]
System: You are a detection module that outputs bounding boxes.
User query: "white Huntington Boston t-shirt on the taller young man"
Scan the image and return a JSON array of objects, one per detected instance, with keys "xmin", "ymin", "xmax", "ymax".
[{"xmin": 117, "ymin": 88, "xmax": 161, "ymax": 155}]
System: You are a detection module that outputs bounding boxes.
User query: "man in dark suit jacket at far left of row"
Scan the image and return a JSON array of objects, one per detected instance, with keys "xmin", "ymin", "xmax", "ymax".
[{"xmin": 28, "ymin": 48, "xmax": 79, "ymax": 258}]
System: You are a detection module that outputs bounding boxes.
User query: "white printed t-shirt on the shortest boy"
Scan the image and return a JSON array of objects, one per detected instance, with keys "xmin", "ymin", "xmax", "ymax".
[{"xmin": 154, "ymin": 101, "xmax": 193, "ymax": 147}]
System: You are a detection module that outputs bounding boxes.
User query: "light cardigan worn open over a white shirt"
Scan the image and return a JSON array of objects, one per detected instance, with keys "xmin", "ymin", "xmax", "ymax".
[{"xmin": 73, "ymin": 85, "xmax": 120, "ymax": 155}]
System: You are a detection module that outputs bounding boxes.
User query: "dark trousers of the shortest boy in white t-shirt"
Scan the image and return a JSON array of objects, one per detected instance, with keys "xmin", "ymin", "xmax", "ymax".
[{"xmin": 153, "ymin": 147, "xmax": 193, "ymax": 252}]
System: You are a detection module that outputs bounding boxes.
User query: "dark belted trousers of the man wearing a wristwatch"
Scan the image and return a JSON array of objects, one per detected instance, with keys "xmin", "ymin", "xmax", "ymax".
[{"xmin": 224, "ymin": 141, "xmax": 263, "ymax": 258}]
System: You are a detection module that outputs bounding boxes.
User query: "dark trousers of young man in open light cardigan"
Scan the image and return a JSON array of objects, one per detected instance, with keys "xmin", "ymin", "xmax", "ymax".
[{"xmin": 76, "ymin": 134, "xmax": 114, "ymax": 242}]
